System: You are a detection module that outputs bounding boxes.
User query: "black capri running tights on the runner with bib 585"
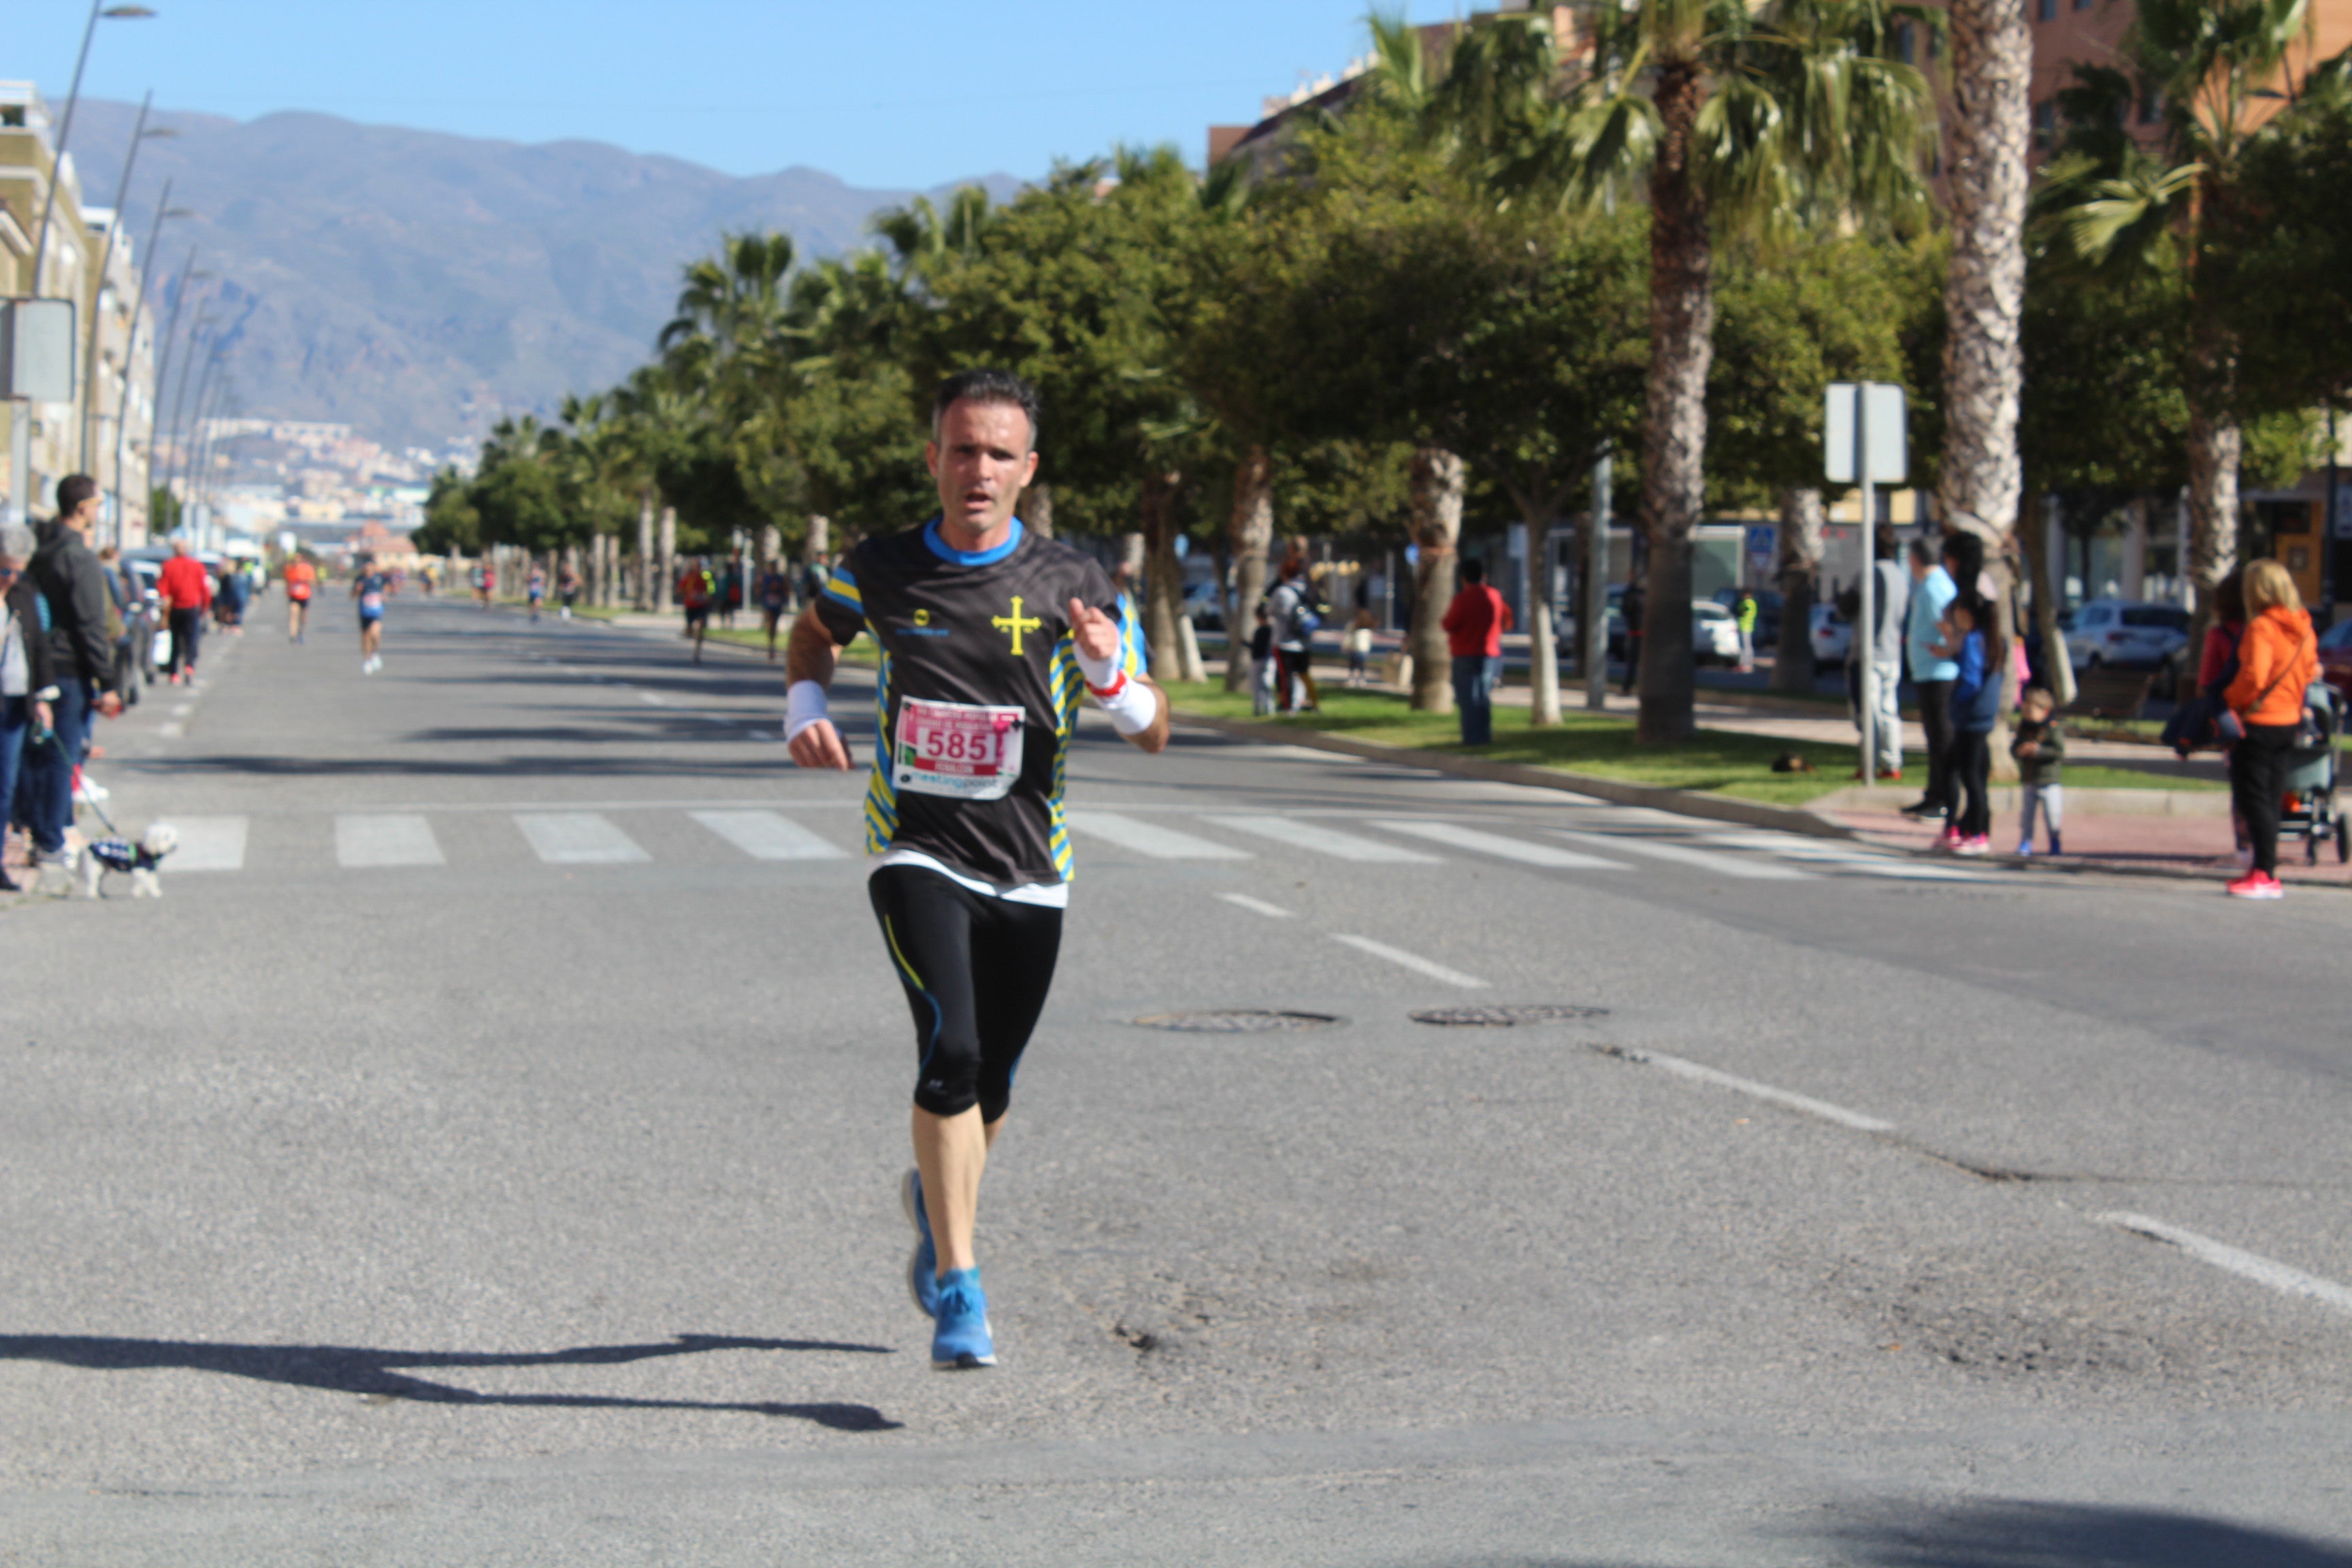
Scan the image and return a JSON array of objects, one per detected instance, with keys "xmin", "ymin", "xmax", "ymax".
[{"xmin": 866, "ymin": 865, "xmax": 1061, "ymax": 1122}]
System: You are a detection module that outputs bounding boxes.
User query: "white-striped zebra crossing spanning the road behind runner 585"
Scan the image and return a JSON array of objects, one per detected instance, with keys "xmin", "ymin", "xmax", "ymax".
[{"xmin": 142, "ymin": 802, "xmax": 1987, "ymax": 881}]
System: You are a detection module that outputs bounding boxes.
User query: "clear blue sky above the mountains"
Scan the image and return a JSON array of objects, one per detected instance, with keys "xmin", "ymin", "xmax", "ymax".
[{"xmin": 27, "ymin": 0, "xmax": 1454, "ymax": 186}]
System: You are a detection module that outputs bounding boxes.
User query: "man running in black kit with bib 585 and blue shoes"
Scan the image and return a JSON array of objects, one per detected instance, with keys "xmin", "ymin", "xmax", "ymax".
[{"xmin": 783, "ymin": 369, "xmax": 1169, "ymax": 1371}]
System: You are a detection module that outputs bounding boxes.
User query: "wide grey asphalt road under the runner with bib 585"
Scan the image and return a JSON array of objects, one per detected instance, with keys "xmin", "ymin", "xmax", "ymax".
[{"xmin": 0, "ymin": 597, "xmax": 2352, "ymax": 1568}]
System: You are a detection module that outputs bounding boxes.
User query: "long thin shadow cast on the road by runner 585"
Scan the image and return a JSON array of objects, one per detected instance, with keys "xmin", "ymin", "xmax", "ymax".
[{"xmin": 0, "ymin": 1333, "xmax": 898, "ymax": 1432}]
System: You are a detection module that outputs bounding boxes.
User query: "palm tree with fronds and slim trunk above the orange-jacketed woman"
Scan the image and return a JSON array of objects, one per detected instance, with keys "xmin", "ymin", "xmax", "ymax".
[{"xmin": 2042, "ymin": 0, "xmax": 2310, "ymax": 634}]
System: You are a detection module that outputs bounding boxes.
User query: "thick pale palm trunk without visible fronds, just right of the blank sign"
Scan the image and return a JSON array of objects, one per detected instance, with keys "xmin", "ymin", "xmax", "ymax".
[{"xmin": 1936, "ymin": 0, "xmax": 2034, "ymax": 559}]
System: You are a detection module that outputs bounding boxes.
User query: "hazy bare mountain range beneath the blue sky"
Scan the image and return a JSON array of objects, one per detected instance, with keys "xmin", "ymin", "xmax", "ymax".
[{"xmin": 73, "ymin": 99, "xmax": 1018, "ymax": 449}]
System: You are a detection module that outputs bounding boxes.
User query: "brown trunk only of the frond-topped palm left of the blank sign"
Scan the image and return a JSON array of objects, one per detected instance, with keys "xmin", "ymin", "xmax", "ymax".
[{"xmin": 1635, "ymin": 59, "xmax": 1714, "ymax": 743}]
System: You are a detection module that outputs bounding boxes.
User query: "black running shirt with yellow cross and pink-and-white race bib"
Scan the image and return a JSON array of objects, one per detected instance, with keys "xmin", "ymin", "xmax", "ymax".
[{"xmin": 814, "ymin": 517, "xmax": 1143, "ymax": 891}]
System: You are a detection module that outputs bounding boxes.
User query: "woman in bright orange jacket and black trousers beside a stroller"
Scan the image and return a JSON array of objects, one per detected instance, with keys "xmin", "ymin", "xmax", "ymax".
[{"xmin": 2223, "ymin": 559, "xmax": 2319, "ymax": 898}]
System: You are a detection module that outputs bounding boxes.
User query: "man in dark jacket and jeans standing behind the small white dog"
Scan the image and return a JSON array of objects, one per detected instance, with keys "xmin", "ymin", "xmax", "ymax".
[{"xmin": 24, "ymin": 472, "xmax": 122, "ymax": 872}]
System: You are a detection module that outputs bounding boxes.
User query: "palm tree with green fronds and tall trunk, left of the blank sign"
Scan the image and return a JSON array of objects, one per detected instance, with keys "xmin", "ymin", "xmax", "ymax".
[{"xmin": 1439, "ymin": 0, "xmax": 1928, "ymax": 740}]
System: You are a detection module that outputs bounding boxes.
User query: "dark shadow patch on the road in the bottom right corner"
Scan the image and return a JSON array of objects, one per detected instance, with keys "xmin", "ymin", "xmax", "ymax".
[{"xmin": 1835, "ymin": 1502, "xmax": 2352, "ymax": 1568}]
